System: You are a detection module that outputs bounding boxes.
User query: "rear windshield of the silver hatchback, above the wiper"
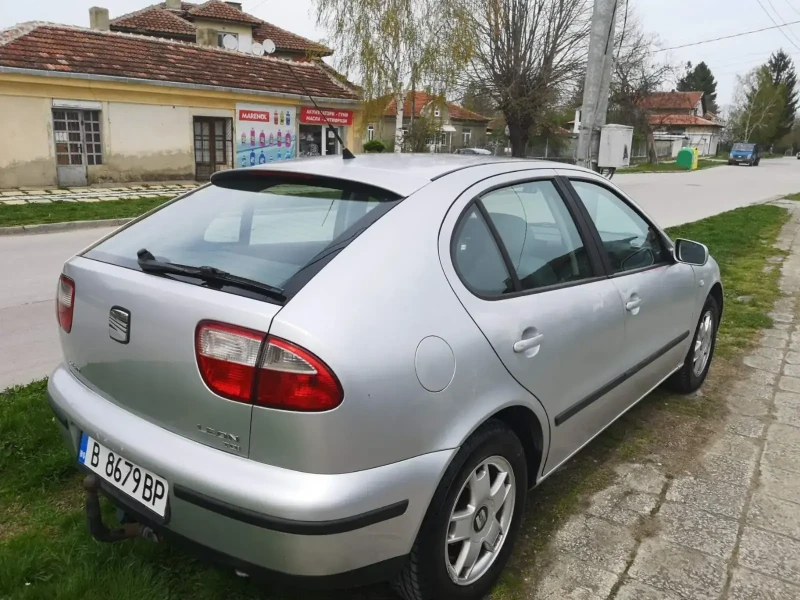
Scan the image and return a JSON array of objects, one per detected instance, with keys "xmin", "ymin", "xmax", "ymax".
[{"xmin": 84, "ymin": 171, "xmax": 400, "ymax": 296}]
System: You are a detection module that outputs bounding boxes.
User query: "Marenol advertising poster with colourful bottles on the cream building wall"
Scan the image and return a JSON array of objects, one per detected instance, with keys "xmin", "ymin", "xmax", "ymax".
[{"xmin": 234, "ymin": 104, "xmax": 297, "ymax": 167}]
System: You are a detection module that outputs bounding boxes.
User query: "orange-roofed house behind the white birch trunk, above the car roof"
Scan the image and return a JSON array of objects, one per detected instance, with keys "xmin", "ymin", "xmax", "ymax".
[{"xmin": 366, "ymin": 92, "xmax": 491, "ymax": 152}]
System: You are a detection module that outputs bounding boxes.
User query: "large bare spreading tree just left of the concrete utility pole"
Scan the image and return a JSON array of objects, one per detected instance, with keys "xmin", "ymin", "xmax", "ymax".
[{"xmin": 462, "ymin": 0, "xmax": 589, "ymax": 157}]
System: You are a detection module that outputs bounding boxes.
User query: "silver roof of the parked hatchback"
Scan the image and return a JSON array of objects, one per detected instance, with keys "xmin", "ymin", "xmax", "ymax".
[{"xmin": 225, "ymin": 153, "xmax": 564, "ymax": 196}]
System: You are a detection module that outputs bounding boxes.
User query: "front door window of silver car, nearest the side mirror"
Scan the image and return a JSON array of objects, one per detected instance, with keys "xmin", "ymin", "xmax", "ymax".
[{"xmin": 572, "ymin": 181, "xmax": 667, "ymax": 273}]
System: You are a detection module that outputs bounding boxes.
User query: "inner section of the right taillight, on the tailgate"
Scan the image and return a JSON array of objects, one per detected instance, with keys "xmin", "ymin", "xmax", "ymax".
[{"xmin": 195, "ymin": 321, "xmax": 266, "ymax": 402}]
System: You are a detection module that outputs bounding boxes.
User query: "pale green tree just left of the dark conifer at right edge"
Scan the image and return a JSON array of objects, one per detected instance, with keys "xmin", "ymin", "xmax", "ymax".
[{"xmin": 728, "ymin": 65, "xmax": 785, "ymax": 144}]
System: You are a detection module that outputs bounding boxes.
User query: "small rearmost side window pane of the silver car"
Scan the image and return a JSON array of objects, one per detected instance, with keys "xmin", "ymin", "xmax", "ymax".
[{"xmin": 452, "ymin": 204, "xmax": 514, "ymax": 296}]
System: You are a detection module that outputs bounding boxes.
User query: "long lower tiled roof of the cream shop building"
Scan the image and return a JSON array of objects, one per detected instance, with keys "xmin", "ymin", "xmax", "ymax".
[{"xmin": 0, "ymin": 24, "xmax": 358, "ymax": 100}]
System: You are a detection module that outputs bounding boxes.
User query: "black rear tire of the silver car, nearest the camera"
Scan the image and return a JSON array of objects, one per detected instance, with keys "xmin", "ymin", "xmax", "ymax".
[{"xmin": 392, "ymin": 419, "xmax": 528, "ymax": 600}]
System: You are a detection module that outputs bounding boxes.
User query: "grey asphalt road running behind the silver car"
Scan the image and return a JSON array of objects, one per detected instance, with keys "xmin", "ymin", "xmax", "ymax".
[{"xmin": 0, "ymin": 158, "xmax": 800, "ymax": 390}]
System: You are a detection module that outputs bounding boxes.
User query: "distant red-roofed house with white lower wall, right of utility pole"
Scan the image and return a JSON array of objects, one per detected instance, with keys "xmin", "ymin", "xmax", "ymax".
[{"xmin": 639, "ymin": 92, "xmax": 724, "ymax": 155}]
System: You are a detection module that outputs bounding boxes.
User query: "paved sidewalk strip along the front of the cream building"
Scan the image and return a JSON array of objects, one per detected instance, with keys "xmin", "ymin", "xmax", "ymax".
[{"xmin": 0, "ymin": 183, "xmax": 198, "ymax": 205}]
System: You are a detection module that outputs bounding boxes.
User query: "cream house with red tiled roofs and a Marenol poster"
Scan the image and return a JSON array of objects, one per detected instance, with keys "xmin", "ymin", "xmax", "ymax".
[{"xmin": 0, "ymin": 0, "xmax": 362, "ymax": 188}]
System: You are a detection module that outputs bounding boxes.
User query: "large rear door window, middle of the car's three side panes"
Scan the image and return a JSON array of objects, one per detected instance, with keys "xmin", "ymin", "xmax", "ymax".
[{"xmin": 481, "ymin": 181, "xmax": 593, "ymax": 290}]
